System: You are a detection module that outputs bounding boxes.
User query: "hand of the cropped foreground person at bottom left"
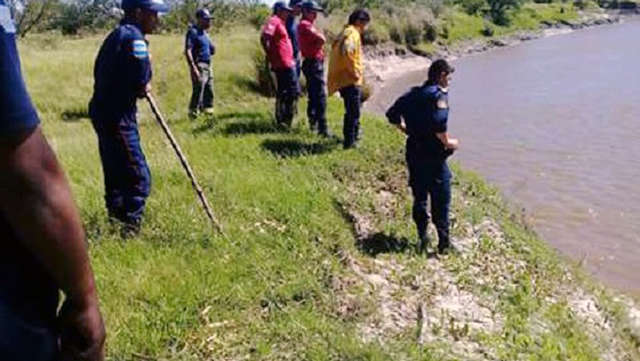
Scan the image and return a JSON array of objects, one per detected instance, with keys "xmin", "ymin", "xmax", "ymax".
[{"xmin": 58, "ymin": 297, "xmax": 106, "ymax": 361}]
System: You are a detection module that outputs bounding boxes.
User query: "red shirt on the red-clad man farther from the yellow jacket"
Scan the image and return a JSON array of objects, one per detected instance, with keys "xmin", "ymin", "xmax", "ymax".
[{"xmin": 262, "ymin": 15, "xmax": 296, "ymax": 70}]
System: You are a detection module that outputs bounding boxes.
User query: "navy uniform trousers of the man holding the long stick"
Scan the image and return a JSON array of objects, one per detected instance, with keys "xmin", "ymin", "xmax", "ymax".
[{"xmin": 93, "ymin": 111, "xmax": 151, "ymax": 225}]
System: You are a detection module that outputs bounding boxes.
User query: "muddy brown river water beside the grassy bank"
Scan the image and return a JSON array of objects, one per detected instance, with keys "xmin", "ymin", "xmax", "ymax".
[{"xmin": 368, "ymin": 20, "xmax": 640, "ymax": 294}]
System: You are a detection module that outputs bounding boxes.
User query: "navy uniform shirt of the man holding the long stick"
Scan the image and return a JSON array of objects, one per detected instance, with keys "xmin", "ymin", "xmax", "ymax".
[{"xmin": 89, "ymin": 20, "xmax": 151, "ymax": 116}]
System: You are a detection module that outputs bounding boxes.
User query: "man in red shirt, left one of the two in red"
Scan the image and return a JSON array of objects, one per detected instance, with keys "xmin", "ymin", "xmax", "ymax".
[{"xmin": 260, "ymin": 1, "xmax": 299, "ymax": 127}]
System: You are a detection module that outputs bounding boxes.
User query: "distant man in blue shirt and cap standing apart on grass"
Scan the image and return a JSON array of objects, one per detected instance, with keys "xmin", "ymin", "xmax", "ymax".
[{"xmin": 184, "ymin": 9, "xmax": 216, "ymax": 118}]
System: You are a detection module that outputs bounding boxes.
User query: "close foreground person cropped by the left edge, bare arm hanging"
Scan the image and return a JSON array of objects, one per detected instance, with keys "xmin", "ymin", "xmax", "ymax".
[{"xmin": 0, "ymin": 0, "xmax": 105, "ymax": 361}]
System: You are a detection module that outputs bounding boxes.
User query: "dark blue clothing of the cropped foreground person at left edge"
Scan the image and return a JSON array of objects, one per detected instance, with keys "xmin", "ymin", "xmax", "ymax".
[{"xmin": 0, "ymin": 0, "xmax": 58, "ymax": 360}]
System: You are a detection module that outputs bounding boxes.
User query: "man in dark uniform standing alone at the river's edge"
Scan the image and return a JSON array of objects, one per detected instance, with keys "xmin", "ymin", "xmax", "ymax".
[{"xmin": 386, "ymin": 59, "xmax": 459, "ymax": 254}]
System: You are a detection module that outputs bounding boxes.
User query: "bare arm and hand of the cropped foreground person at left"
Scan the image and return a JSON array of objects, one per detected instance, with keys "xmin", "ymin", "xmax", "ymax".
[{"xmin": 0, "ymin": 127, "xmax": 105, "ymax": 360}]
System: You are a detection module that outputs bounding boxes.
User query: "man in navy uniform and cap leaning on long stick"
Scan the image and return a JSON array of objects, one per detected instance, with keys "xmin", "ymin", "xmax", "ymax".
[{"xmin": 89, "ymin": 0, "xmax": 168, "ymax": 233}]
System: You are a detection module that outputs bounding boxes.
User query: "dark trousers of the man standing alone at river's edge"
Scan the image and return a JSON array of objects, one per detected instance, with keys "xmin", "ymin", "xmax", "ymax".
[{"xmin": 407, "ymin": 154, "xmax": 451, "ymax": 248}]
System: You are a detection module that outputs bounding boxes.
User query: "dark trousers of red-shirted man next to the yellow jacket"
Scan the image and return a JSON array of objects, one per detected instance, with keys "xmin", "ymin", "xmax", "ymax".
[{"xmin": 302, "ymin": 59, "xmax": 328, "ymax": 134}]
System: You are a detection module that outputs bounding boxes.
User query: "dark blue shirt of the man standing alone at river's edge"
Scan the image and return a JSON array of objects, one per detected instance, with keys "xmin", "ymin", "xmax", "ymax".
[{"xmin": 386, "ymin": 83, "xmax": 450, "ymax": 160}]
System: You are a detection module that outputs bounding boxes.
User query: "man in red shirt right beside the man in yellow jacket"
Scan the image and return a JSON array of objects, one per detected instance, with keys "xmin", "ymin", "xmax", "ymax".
[{"xmin": 298, "ymin": 0, "xmax": 329, "ymax": 137}]
